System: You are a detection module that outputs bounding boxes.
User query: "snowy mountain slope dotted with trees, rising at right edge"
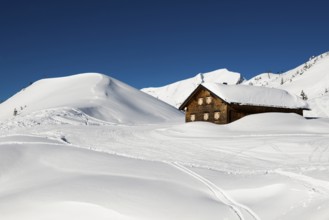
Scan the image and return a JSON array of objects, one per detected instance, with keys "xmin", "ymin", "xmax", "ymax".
[{"xmin": 244, "ymin": 52, "xmax": 329, "ymax": 99}]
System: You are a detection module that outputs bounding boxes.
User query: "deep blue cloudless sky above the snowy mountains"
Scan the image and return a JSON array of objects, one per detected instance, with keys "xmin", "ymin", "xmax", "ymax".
[{"xmin": 0, "ymin": 0, "xmax": 329, "ymax": 101}]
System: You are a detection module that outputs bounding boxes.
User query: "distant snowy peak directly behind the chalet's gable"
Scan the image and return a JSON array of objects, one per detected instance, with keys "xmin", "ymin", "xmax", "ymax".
[{"xmin": 142, "ymin": 69, "xmax": 244, "ymax": 108}]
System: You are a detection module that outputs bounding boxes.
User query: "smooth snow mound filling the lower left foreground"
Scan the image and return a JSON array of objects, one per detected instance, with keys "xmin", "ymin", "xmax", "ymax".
[{"xmin": 0, "ymin": 140, "xmax": 236, "ymax": 220}]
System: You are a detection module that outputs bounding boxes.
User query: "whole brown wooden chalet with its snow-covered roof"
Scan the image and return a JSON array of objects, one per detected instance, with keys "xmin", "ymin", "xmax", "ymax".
[{"xmin": 179, "ymin": 83, "xmax": 309, "ymax": 124}]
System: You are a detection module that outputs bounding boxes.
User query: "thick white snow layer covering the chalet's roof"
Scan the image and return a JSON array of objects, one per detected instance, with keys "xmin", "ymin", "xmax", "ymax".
[{"xmin": 182, "ymin": 83, "xmax": 308, "ymax": 109}]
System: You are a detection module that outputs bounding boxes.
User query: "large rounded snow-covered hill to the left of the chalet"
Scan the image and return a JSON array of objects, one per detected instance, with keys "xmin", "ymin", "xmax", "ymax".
[{"xmin": 0, "ymin": 73, "xmax": 182, "ymax": 124}]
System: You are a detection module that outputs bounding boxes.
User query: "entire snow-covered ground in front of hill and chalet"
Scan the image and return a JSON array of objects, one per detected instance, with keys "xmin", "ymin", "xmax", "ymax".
[{"xmin": 0, "ymin": 109, "xmax": 329, "ymax": 220}]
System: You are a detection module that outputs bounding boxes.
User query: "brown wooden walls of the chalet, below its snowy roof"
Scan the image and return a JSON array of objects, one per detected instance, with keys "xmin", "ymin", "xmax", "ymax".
[{"xmin": 179, "ymin": 85, "xmax": 303, "ymax": 124}]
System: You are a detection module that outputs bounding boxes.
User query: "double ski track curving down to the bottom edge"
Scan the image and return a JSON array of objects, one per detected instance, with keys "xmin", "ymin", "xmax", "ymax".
[{"xmin": 170, "ymin": 162, "xmax": 260, "ymax": 220}]
